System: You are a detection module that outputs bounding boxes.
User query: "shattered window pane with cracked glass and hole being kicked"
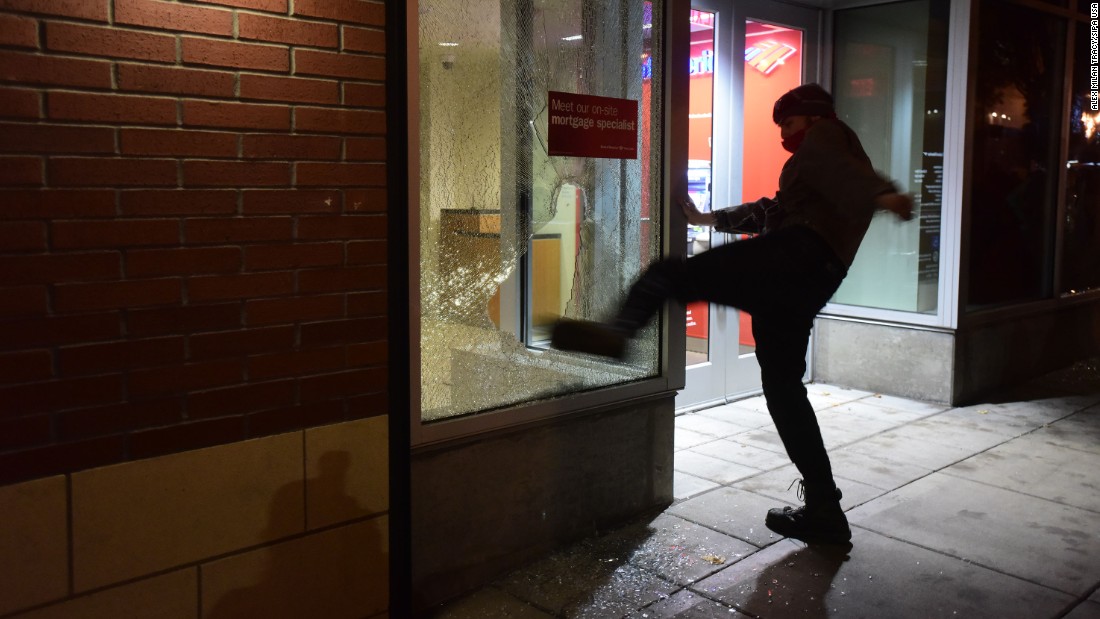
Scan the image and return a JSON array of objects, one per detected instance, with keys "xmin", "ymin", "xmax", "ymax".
[{"xmin": 418, "ymin": 0, "xmax": 663, "ymax": 421}]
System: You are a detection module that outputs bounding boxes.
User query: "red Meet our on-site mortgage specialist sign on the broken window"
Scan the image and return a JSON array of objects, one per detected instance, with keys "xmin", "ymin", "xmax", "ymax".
[{"xmin": 547, "ymin": 90, "xmax": 638, "ymax": 159}]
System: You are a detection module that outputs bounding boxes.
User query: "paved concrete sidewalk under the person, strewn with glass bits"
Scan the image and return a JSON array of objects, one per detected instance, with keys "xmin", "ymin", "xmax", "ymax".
[{"xmin": 433, "ymin": 362, "xmax": 1100, "ymax": 619}]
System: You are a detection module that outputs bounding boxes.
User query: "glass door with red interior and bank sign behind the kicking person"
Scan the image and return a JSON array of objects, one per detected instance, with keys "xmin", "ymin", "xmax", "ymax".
[{"xmin": 677, "ymin": 0, "xmax": 821, "ymax": 409}]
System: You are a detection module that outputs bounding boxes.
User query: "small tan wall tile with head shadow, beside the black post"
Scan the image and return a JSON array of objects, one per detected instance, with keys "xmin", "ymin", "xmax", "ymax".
[{"xmin": 306, "ymin": 417, "xmax": 389, "ymax": 529}]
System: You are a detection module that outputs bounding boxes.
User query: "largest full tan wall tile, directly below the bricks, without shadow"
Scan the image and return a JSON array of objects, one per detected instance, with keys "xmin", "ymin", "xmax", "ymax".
[{"xmin": 72, "ymin": 432, "xmax": 305, "ymax": 593}]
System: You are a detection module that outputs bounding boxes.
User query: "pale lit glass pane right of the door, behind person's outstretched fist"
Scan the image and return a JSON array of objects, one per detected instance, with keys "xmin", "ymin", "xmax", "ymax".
[{"xmin": 833, "ymin": 0, "xmax": 949, "ymax": 314}]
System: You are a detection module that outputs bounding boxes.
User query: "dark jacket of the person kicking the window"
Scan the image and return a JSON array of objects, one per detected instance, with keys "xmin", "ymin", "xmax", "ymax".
[{"xmin": 714, "ymin": 119, "xmax": 898, "ymax": 266}]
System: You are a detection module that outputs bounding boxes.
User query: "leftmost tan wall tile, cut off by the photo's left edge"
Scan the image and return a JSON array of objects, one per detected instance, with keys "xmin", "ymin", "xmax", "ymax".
[{"xmin": 0, "ymin": 476, "xmax": 68, "ymax": 615}]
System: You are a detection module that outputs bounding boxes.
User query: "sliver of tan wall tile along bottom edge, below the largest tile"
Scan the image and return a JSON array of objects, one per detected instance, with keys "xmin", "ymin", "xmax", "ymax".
[{"xmin": 11, "ymin": 567, "xmax": 199, "ymax": 619}]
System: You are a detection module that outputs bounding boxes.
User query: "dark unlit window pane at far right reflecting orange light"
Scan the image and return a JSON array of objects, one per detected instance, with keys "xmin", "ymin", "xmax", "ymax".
[{"xmin": 967, "ymin": 0, "xmax": 1066, "ymax": 310}]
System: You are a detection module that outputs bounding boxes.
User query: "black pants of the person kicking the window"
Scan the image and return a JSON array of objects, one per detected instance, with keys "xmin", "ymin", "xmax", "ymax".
[{"xmin": 615, "ymin": 226, "xmax": 847, "ymax": 501}]
